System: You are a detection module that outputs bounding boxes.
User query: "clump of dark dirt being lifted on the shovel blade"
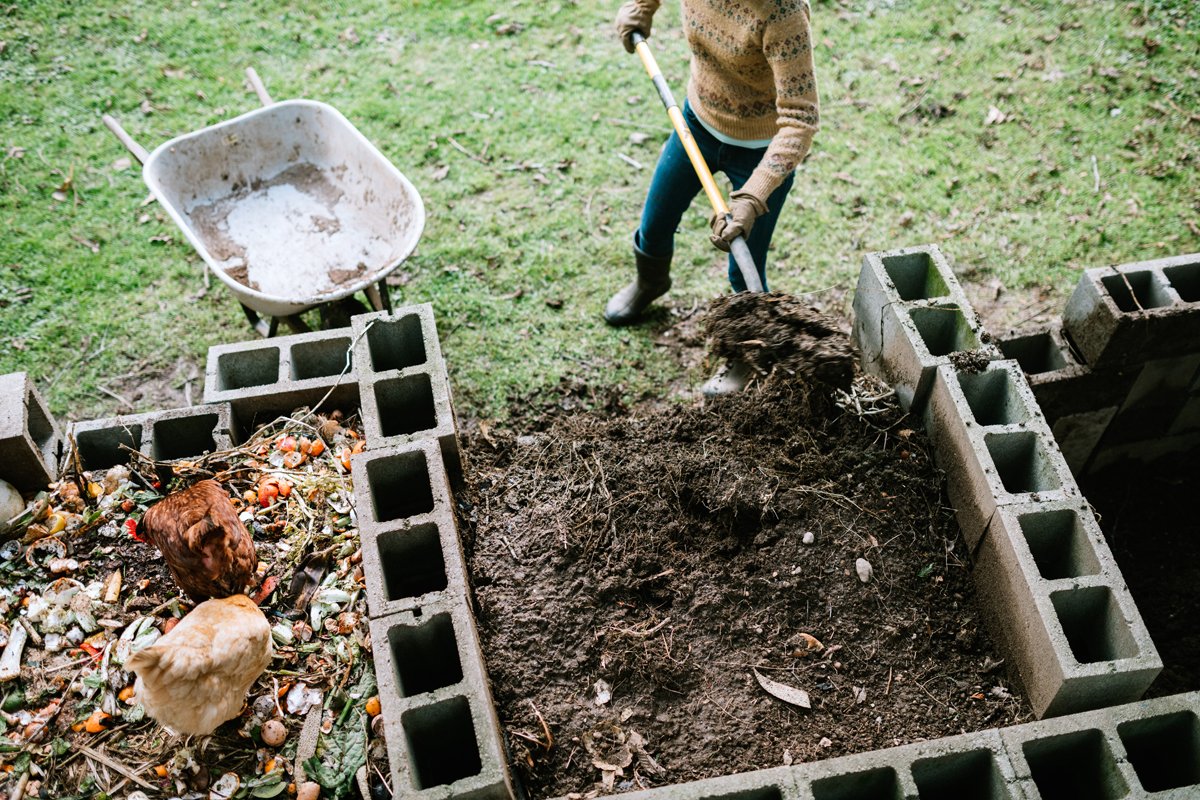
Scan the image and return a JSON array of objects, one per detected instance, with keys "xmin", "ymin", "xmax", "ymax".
[{"xmin": 704, "ymin": 291, "xmax": 854, "ymax": 389}]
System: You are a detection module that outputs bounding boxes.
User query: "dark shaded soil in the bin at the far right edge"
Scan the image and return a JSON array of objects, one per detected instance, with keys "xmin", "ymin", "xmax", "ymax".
[{"xmin": 1082, "ymin": 455, "xmax": 1200, "ymax": 697}]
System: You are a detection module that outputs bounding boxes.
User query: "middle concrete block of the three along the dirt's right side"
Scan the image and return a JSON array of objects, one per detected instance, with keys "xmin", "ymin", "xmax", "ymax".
[{"xmin": 924, "ymin": 361, "xmax": 1081, "ymax": 551}]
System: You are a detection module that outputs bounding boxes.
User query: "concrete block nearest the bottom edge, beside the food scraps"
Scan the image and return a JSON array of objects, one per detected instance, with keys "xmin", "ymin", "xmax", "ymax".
[{"xmin": 371, "ymin": 599, "xmax": 512, "ymax": 800}]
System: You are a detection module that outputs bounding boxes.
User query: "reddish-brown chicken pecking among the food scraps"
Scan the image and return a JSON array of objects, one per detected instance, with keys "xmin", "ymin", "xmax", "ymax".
[{"xmin": 137, "ymin": 481, "xmax": 258, "ymax": 601}]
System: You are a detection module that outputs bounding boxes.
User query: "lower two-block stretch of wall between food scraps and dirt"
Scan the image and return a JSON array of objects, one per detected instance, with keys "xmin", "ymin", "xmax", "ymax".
[{"xmin": 352, "ymin": 438, "xmax": 512, "ymax": 800}]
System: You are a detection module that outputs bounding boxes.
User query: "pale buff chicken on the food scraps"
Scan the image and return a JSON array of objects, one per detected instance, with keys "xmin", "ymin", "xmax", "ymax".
[{"xmin": 125, "ymin": 595, "xmax": 274, "ymax": 735}]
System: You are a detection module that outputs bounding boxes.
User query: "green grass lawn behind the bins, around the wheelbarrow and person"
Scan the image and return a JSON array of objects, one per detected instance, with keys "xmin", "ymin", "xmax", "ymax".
[{"xmin": 0, "ymin": 0, "xmax": 1200, "ymax": 419}]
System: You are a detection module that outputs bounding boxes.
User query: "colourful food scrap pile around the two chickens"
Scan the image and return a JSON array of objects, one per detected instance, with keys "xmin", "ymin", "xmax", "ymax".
[{"xmin": 0, "ymin": 411, "xmax": 389, "ymax": 800}]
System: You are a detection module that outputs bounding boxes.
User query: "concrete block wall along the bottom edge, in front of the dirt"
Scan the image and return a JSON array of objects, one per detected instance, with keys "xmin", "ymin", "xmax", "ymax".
[{"xmin": 595, "ymin": 693, "xmax": 1200, "ymax": 800}]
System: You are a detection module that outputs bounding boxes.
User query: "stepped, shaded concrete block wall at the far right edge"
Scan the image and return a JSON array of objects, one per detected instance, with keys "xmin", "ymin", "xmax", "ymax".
[{"xmin": 998, "ymin": 254, "xmax": 1200, "ymax": 475}]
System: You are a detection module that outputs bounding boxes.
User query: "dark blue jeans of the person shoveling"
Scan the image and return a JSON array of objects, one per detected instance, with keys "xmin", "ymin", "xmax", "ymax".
[{"xmin": 634, "ymin": 101, "xmax": 796, "ymax": 291}]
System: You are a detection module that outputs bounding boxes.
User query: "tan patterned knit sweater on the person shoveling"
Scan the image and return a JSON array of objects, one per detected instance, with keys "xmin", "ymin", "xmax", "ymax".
[{"xmin": 634, "ymin": 0, "xmax": 820, "ymax": 199}]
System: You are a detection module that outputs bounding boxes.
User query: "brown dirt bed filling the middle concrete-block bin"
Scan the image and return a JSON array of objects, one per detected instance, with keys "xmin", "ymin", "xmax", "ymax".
[{"xmin": 460, "ymin": 373, "xmax": 1030, "ymax": 798}]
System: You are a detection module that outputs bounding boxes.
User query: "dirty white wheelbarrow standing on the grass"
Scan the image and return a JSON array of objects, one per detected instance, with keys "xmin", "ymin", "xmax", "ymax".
[{"xmin": 103, "ymin": 68, "xmax": 425, "ymax": 336}]
